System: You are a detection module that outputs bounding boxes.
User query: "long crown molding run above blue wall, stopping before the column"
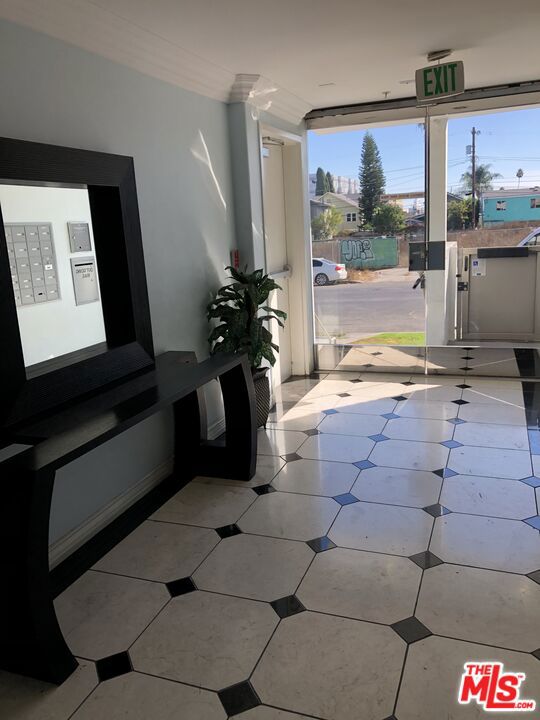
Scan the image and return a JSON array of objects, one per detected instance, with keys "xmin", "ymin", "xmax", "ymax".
[{"xmin": 0, "ymin": 0, "xmax": 235, "ymax": 102}]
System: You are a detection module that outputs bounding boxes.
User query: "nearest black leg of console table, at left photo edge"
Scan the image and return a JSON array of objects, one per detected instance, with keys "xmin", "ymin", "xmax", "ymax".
[{"xmin": 0, "ymin": 462, "xmax": 77, "ymax": 684}]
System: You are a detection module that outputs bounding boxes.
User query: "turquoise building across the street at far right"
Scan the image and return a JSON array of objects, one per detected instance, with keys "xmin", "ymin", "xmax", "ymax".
[{"xmin": 480, "ymin": 186, "xmax": 540, "ymax": 227}]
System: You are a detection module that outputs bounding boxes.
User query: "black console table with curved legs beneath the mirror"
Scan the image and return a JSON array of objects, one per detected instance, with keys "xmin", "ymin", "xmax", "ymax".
[{"xmin": 0, "ymin": 352, "xmax": 257, "ymax": 684}]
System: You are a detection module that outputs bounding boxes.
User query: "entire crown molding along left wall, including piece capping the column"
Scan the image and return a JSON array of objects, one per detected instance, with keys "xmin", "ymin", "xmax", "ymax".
[{"xmin": 0, "ymin": 0, "xmax": 312, "ymax": 124}]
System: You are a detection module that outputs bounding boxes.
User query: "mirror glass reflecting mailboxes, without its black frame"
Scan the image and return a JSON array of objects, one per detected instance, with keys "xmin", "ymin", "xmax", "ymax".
[{"xmin": 0, "ymin": 181, "xmax": 107, "ymax": 378}]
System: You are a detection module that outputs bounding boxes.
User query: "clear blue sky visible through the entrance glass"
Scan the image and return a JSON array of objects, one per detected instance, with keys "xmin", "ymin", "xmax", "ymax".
[{"xmin": 308, "ymin": 108, "xmax": 540, "ymax": 193}]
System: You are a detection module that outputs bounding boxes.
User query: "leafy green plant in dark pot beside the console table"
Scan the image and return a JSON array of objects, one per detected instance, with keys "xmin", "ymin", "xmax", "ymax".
[{"xmin": 207, "ymin": 267, "xmax": 287, "ymax": 427}]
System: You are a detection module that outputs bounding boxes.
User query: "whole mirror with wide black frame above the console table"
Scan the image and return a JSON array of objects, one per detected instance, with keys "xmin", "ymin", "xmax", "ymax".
[{"xmin": 0, "ymin": 139, "xmax": 154, "ymax": 431}]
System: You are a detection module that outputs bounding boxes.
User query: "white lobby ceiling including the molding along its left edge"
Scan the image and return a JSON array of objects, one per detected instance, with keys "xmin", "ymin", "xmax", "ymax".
[{"xmin": 0, "ymin": 0, "xmax": 540, "ymax": 119}]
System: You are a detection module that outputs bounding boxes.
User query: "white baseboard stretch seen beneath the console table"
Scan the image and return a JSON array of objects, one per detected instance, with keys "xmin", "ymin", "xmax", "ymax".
[{"xmin": 49, "ymin": 458, "xmax": 173, "ymax": 568}]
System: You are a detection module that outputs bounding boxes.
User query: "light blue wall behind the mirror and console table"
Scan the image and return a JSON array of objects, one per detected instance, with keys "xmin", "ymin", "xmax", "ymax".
[{"xmin": 0, "ymin": 21, "xmax": 235, "ymax": 540}]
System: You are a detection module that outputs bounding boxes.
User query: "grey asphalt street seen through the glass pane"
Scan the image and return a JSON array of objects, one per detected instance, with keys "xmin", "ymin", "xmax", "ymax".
[{"xmin": 313, "ymin": 275, "xmax": 424, "ymax": 339}]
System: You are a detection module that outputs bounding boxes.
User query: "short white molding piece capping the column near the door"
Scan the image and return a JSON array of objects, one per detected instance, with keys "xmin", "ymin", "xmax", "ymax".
[{"xmin": 229, "ymin": 73, "xmax": 311, "ymax": 125}]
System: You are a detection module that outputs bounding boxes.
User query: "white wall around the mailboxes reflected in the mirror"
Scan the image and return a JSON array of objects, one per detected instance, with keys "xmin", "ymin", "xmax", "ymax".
[{"xmin": 0, "ymin": 185, "xmax": 106, "ymax": 367}]
